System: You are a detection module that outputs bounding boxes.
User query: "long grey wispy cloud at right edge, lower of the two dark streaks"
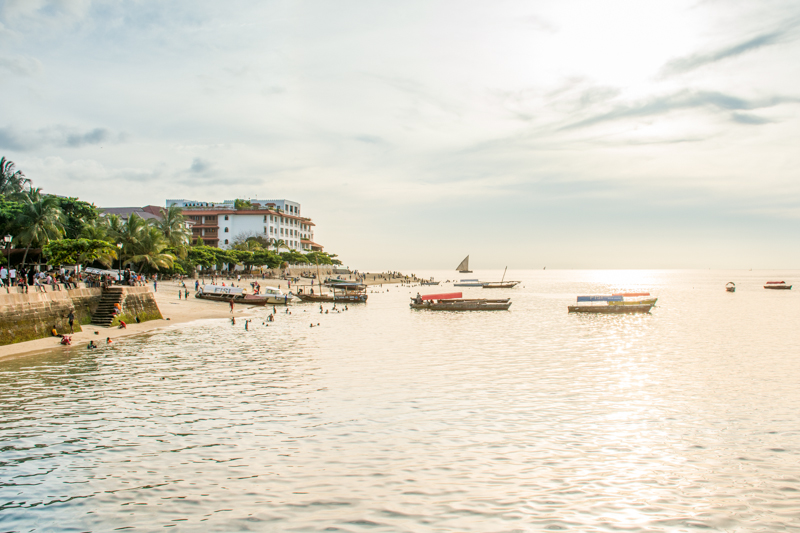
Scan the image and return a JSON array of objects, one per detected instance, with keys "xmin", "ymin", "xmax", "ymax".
[{"xmin": 560, "ymin": 90, "xmax": 798, "ymax": 130}]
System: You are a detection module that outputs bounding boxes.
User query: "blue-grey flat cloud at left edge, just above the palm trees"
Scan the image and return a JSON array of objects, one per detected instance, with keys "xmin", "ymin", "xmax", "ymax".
[{"xmin": 0, "ymin": 126, "xmax": 128, "ymax": 152}]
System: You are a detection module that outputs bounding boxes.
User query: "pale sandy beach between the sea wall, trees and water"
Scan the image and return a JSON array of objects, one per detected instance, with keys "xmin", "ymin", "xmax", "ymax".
[{"xmin": 0, "ymin": 274, "xmax": 403, "ymax": 360}]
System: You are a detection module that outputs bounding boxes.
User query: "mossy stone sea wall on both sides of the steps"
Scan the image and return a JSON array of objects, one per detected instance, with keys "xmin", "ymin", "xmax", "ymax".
[{"xmin": 0, "ymin": 286, "xmax": 161, "ymax": 346}]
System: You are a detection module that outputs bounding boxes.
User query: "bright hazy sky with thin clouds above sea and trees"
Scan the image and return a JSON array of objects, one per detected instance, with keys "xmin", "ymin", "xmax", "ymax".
[{"xmin": 0, "ymin": 0, "xmax": 800, "ymax": 270}]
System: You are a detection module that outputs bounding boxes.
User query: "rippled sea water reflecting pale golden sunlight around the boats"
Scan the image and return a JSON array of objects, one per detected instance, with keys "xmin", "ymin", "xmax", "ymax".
[{"xmin": 0, "ymin": 271, "xmax": 800, "ymax": 532}]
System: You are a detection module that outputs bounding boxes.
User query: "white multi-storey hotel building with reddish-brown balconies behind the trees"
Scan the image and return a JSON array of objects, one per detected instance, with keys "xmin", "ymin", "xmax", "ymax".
[{"xmin": 167, "ymin": 199, "xmax": 322, "ymax": 252}]
